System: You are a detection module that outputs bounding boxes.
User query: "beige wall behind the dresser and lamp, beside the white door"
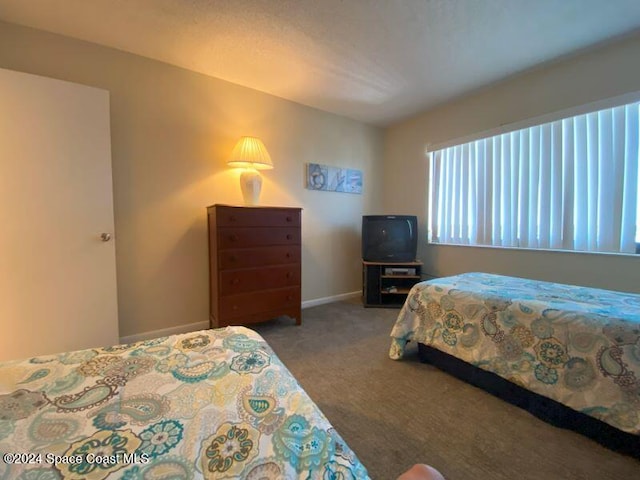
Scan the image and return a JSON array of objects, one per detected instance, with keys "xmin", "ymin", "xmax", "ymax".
[{"xmin": 0, "ymin": 23, "xmax": 382, "ymax": 336}]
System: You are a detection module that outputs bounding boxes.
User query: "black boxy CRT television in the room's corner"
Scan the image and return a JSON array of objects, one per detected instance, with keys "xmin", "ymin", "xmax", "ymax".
[{"xmin": 362, "ymin": 215, "xmax": 418, "ymax": 262}]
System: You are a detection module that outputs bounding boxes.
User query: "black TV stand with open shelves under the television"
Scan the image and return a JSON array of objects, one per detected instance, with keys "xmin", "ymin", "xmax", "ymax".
[{"xmin": 362, "ymin": 260, "xmax": 422, "ymax": 308}]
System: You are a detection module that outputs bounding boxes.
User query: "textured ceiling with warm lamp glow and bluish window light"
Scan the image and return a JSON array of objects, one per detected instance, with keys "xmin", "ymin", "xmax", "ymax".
[{"xmin": 0, "ymin": 0, "xmax": 640, "ymax": 125}]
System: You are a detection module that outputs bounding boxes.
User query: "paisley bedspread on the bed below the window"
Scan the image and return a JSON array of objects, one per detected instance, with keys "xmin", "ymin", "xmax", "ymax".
[{"xmin": 390, "ymin": 273, "xmax": 640, "ymax": 435}]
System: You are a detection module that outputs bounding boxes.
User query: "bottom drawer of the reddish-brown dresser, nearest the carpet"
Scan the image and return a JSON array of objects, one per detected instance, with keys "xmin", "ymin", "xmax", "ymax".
[{"xmin": 219, "ymin": 287, "xmax": 300, "ymax": 321}]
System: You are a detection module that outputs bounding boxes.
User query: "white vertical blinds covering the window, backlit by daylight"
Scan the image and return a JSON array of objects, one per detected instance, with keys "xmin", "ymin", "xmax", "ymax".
[{"xmin": 429, "ymin": 103, "xmax": 640, "ymax": 253}]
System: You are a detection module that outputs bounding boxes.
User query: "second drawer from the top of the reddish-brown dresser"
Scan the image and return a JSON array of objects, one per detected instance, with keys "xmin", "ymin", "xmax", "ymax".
[{"xmin": 218, "ymin": 227, "xmax": 300, "ymax": 249}]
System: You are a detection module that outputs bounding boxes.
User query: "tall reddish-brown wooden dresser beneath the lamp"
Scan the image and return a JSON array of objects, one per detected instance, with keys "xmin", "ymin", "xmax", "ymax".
[{"xmin": 207, "ymin": 205, "xmax": 302, "ymax": 328}]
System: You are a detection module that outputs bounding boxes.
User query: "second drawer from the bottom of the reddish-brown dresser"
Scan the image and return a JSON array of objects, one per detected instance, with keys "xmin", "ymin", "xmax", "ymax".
[{"xmin": 220, "ymin": 264, "xmax": 300, "ymax": 294}]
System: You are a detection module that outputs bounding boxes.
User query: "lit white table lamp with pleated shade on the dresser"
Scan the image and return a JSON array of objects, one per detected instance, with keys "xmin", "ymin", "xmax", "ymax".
[{"xmin": 227, "ymin": 137, "xmax": 273, "ymax": 205}]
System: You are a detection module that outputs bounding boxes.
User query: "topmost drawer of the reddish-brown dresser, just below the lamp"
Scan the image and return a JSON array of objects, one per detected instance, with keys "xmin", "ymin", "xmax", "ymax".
[{"xmin": 216, "ymin": 207, "xmax": 300, "ymax": 227}]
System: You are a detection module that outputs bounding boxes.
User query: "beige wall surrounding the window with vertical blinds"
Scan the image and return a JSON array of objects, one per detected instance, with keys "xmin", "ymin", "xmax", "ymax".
[{"xmin": 384, "ymin": 35, "xmax": 640, "ymax": 292}]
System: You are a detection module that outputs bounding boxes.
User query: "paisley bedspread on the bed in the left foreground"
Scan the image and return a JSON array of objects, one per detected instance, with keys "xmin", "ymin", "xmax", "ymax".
[{"xmin": 0, "ymin": 327, "xmax": 369, "ymax": 480}]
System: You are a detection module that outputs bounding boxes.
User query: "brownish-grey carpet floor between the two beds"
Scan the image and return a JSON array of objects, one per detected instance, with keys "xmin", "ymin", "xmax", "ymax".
[{"xmin": 254, "ymin": 300, "xmax": 640, "ymax": 480}]
